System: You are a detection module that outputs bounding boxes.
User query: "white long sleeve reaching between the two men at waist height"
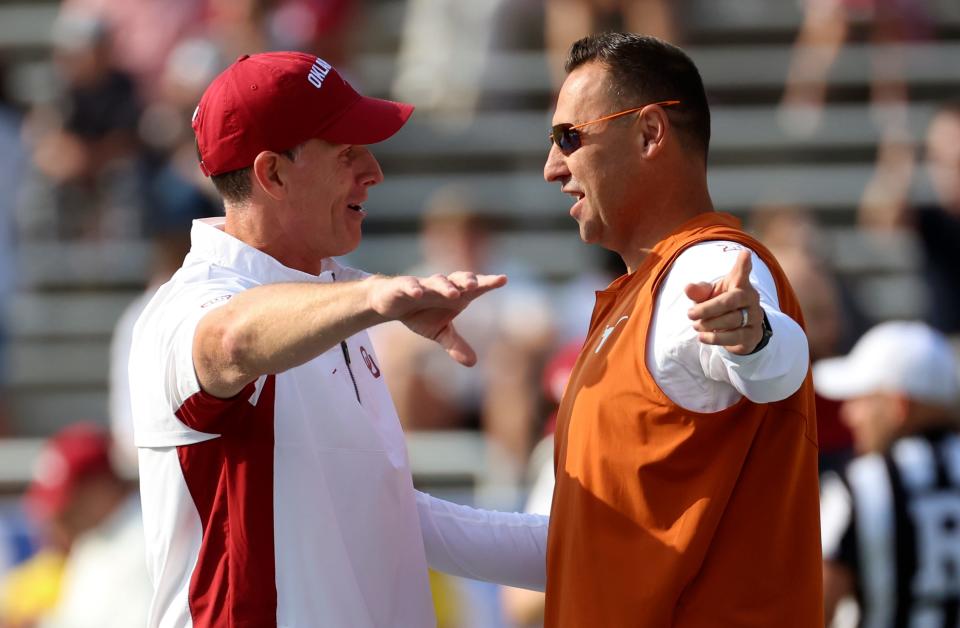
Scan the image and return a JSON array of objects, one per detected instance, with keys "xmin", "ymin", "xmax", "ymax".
[{"xmin": 416, "ymin": 491, "xmax": 549, "ymax": 591}]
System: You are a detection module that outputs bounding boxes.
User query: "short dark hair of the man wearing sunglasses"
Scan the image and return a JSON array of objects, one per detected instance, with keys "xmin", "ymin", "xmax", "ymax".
[{"xmin": 566, "ymin": 33, "xmax": 710, "ymax": 159}]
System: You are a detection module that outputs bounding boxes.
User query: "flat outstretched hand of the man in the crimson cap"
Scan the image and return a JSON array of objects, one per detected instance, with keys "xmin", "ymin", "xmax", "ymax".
[{"xmin": 367, "ymin": 271, "xmax": 507, "ymax": 366}]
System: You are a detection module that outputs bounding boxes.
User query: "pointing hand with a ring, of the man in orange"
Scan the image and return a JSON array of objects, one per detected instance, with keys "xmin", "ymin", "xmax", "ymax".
[{"xmin": 684, "ymin": 251, "xmax": 763, "ymax": 355}]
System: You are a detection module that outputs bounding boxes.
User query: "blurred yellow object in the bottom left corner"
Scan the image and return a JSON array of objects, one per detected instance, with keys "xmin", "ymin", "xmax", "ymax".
[{"xmin": 0, "ymin": 550, "xmax": 66, "ymax": 625}]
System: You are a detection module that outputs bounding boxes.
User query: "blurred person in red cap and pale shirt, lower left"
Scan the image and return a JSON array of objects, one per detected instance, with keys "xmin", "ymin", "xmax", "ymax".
[{"xmin": 25, "ymin": 423, "xmax": 152, "ymax": 628}]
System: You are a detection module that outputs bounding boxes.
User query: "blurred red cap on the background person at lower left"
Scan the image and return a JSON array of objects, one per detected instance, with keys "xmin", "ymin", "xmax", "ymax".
[{"xmin": 25, "ymin": 423, "xmax": 112, "ymax": 519}]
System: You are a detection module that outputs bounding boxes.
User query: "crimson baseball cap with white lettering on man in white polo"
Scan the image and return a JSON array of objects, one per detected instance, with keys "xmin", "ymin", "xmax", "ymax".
[{"xmin": 193, "ymin": 52, "xmax": 413, "ymax": 176}]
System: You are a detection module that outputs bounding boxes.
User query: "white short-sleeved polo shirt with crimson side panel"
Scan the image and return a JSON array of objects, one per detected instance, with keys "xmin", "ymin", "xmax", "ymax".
[{"xmin": 130, "ymin": 218, "xmax": 436, "ymax": 628}]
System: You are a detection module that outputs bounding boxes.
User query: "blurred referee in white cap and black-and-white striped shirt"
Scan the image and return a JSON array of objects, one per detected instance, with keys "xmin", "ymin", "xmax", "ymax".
[{"xmin": 813, "ymin": 321, "xmax": 960, "ymax": 628}]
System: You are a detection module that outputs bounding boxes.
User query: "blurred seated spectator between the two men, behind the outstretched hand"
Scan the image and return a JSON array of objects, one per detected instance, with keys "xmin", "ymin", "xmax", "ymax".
[{"xmin": 374, "ymin": 188, "xmax": 552, "ymax": 478}]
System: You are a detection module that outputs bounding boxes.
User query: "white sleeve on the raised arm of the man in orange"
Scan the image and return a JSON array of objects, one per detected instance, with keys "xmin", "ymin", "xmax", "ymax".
[{"xmin": 652, "ymin": 241, "xmax": 810, "ymax": 403}]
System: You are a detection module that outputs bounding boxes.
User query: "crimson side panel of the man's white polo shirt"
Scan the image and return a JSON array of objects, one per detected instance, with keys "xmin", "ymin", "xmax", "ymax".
[{"xmin": 176, "ymin": 375, "xmax": 277, "ymax": 628}]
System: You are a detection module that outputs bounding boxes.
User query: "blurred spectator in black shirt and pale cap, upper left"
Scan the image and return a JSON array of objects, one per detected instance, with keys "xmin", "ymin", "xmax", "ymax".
[{"xmin": 23, "ymin": 13, "xmax": 140, "ymax": 238}]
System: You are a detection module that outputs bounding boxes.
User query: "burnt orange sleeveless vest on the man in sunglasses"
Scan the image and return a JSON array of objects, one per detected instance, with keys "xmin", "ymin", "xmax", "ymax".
[{"xmin": 545, "ymin": 213, "xmax": 823, "ymax": 628}]
